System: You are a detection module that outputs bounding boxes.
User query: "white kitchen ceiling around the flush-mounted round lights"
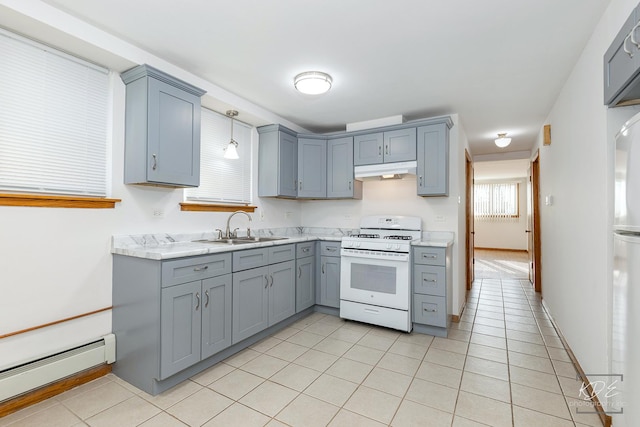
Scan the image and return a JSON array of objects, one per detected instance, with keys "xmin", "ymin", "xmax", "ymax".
[{"xmin": 38, "ymin": 0, "xmax": 609, "ymax": 155}]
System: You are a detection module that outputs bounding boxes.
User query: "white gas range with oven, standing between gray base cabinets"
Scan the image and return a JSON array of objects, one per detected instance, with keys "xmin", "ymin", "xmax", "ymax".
[{"xmin": 340, "ymin": 215, "xmax": 422, "ymax": 332}]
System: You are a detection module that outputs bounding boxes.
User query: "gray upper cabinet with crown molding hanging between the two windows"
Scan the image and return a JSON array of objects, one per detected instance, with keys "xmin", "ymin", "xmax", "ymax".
[{"xmin": 121, "ymin": 65, "xmax": 205, "ymax": 187}]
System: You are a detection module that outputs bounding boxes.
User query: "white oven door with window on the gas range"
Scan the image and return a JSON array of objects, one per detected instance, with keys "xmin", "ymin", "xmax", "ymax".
[{"xmin": 340, "ymin": 248, "xmax": 410, "ymax": 310}]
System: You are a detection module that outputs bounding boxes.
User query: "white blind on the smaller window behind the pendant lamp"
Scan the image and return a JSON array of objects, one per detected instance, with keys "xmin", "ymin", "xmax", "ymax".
[{"xmin": 185, "ymin": 108, "xmax": 251, "ymax": 204}]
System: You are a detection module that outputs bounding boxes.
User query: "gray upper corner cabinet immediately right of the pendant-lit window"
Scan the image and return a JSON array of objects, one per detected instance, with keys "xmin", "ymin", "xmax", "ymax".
[{"xmin": 258, "ymin": 125, "xmax": 298, "ymax": 198}]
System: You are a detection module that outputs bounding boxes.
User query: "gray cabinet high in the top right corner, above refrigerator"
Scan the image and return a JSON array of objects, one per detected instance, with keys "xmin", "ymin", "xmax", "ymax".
[{"xmin": 604, "ymin": 8, "xmax": 640, "ymax": 105}]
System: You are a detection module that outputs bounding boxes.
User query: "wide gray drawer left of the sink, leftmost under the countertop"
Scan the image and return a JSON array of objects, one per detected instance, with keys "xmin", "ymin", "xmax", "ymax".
[{"xmin": 162, "ymin": 253, "xmax": 231, "ymax": 288}]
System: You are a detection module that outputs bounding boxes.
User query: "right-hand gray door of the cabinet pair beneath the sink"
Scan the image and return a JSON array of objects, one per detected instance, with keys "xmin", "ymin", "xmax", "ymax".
[{"xmin": 269, "ymin": 260, "xmax": 296, "ymax": 326}]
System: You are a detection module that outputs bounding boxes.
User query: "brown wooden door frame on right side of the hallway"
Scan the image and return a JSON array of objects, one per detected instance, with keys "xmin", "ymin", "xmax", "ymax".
[{"xmin": 528, "ymin": 150, "xmax": 542, "ymax": 292}]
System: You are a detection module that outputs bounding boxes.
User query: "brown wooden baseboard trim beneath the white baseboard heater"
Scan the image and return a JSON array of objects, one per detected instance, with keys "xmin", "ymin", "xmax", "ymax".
[{"xmin": 0, "ymin": 363, "xmax": 111, "ymax": 418}]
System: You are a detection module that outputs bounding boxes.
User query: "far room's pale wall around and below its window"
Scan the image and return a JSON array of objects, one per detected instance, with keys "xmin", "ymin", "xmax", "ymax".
[{"xmin": 474, "ymin": 179, "xmax": 528, "ymax": 251}]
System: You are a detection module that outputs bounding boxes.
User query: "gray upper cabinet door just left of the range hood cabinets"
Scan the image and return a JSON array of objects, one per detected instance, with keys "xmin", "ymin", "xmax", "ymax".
[{"xmin": 327, "ymin": 136, "xmax": 355, "ymax": 198}]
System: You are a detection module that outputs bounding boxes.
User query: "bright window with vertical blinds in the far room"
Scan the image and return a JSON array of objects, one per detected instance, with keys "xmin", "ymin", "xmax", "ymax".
[{"xmin": 473, "ymin": 182, "xmax": 520, "ymax": 220}]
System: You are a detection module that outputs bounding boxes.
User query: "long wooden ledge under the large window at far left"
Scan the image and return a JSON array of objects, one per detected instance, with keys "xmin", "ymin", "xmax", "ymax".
[{"xmin": 0, "ymin": 193, "xmax": 121, "ymax": 209}]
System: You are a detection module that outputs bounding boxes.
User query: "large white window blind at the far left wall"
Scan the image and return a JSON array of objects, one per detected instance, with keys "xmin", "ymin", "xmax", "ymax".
[{"xmin": 0, "ymin": 30, "xmax": 109, "ymax": 196}]
